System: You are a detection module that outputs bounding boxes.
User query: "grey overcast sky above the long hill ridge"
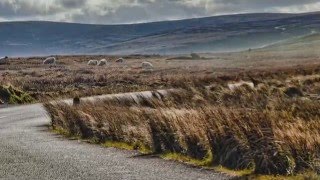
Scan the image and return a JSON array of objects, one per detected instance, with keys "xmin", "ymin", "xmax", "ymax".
[{"xmin": 0, "ymin": 0, "xmax": 320, "ymax": 24}]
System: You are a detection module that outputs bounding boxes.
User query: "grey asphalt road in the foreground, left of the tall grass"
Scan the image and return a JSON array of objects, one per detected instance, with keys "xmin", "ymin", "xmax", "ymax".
[{"xmin": 0, "ymin": 104, "xmax": 229, "ymax": 180}]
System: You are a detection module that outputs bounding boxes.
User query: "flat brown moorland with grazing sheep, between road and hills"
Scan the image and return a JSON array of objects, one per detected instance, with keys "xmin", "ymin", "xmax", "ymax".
[{"xmin": 0, "ymin": 53, "xmax": 320, "ymax": 101}]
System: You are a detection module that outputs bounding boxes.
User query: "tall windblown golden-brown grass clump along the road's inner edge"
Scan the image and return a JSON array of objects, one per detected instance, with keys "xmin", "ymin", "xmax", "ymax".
[{"xmin": 45, "ymin": 73, "xmax": 320, "ymax": 175}]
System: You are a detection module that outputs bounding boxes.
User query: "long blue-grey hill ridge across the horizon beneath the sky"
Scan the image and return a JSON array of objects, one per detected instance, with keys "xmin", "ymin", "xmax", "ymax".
[{"xmin": 0, "ymin": 13, "xmax": 320, "ymax": 56}]
